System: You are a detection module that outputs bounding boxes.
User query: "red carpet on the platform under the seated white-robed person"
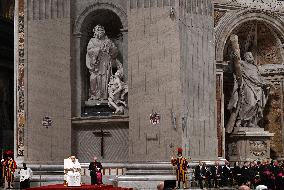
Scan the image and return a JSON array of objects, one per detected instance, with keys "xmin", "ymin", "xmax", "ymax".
[{"xmin": 28, "ymin": 184, "xmax": 133, "ymax": 190}]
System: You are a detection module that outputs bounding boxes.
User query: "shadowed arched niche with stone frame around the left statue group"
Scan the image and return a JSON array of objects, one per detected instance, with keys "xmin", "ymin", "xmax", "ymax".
[{"xmin": 71, "ymin": 1, "xmax": 128, "ymax": 116}]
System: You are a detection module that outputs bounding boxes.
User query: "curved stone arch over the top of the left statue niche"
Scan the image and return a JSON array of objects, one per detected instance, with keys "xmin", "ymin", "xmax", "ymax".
[{"xmin": 73, "ymin": 2, "xmax": 128, "ymax": 35}]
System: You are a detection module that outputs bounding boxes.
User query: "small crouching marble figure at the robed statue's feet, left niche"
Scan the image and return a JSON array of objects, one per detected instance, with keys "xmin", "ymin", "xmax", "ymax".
[{"xmin": 108, "ymin": 70, "xmax": 128, "ymax": 114}]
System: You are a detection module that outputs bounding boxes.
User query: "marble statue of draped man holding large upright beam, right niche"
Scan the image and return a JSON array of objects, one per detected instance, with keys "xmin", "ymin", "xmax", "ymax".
[{"xmin": 226, "ymin": 35, "xmax": 269, "ymax": 133}]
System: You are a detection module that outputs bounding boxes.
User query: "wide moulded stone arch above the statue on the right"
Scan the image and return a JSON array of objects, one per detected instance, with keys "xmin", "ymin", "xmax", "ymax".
[{"xmin": 215, "ymin": 10, "xmax": 284, "ymax": 62}]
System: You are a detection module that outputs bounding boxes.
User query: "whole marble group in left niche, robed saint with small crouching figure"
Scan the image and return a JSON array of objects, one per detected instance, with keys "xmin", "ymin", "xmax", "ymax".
[{"xmin": 85, "ymin": 25, "xmax": 128, "ymax": 114}]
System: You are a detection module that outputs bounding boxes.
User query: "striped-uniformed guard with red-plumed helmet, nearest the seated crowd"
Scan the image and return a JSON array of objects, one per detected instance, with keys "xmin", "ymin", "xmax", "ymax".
[{"xmin": 171, "ymin": 148, "xmax": 188, "ymax": 189}]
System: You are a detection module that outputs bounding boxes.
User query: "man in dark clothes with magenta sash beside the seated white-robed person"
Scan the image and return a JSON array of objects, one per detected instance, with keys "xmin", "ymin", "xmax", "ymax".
[{"xmin": 89, "ymin": 157, "xmax": 102, "ymax": 185}]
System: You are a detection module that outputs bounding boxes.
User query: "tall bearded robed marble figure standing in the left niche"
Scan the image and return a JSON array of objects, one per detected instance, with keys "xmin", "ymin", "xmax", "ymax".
[{"xmin": 86, "ymin": 25, "xmax": 122, "ymax": 104}]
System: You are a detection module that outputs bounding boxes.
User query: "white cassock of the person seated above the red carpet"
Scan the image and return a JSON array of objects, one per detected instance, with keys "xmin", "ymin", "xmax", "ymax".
[{"xmin": 64, "ymin": 159, "xmax": 81, "ymax": 186}]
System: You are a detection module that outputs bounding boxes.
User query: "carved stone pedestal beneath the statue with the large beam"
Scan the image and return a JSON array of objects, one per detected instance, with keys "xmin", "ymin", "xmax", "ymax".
[{"xmin": 227, "ymin": 127, "xmax": 274, "ymax": 161}]
